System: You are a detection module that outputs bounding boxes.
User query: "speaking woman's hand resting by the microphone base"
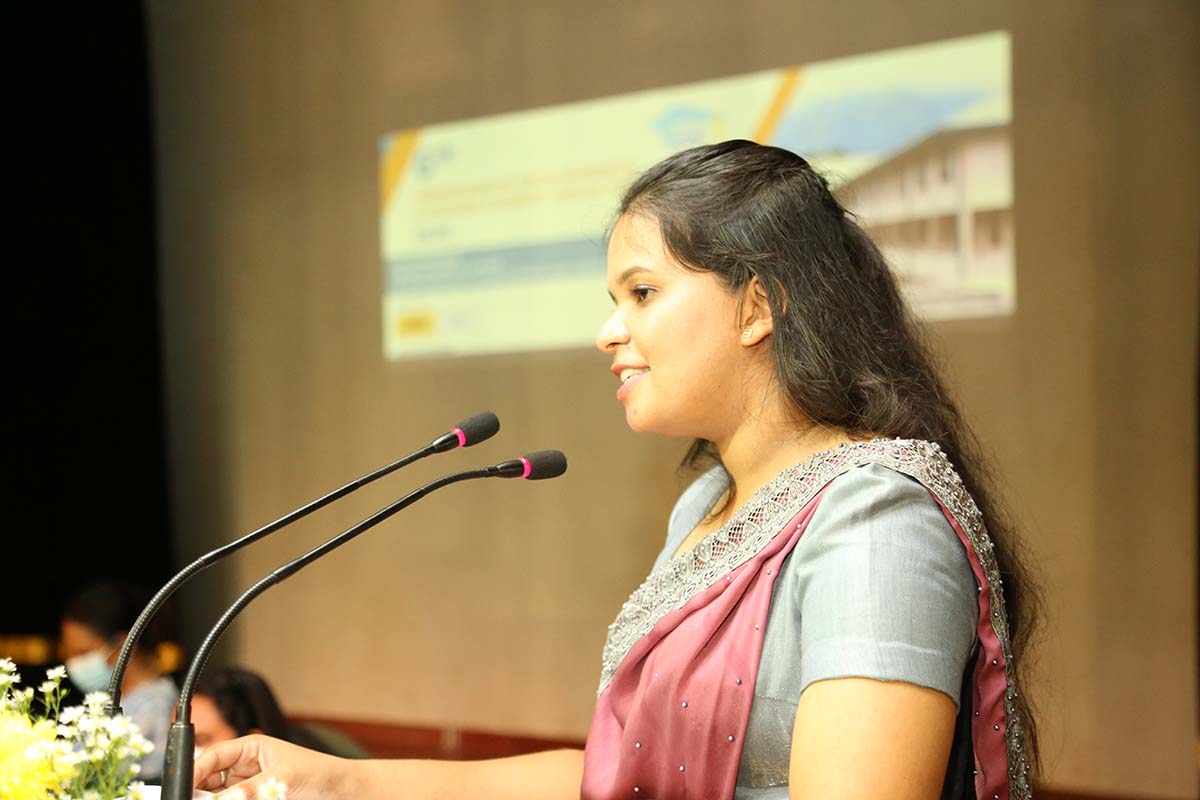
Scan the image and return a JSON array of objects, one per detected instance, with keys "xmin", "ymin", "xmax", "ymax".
[{"xmin": 193, "ymin": 735, "xmax": 355, "ymax": 800}]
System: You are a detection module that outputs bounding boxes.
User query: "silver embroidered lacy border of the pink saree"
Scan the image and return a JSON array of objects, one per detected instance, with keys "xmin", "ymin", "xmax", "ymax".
[{"xmin": 596, "ymin": 439, "xmax": 1032, "ymax": 800}]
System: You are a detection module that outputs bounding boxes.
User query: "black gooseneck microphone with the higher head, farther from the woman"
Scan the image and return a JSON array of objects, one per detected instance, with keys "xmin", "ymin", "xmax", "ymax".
[{"xmin": 106, "ymin": 411, "xmax": 500, "ymax": 716}]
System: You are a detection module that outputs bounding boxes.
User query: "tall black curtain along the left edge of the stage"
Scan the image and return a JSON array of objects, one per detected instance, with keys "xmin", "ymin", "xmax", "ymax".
[{"xmin": 7, "ymin": 4, "xmax": 173, "ymax": 642}]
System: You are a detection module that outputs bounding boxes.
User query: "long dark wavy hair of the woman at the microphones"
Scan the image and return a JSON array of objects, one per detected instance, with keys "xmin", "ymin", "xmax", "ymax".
[{"xmin": 619, "ymin": 140, "xmax": 1037, "ymax": 777}]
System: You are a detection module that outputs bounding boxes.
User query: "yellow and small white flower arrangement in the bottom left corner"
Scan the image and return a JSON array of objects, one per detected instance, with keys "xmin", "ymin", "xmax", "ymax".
[{"xmin": 0, "ymin": 658, "xmax": 154, "ymax": 800}]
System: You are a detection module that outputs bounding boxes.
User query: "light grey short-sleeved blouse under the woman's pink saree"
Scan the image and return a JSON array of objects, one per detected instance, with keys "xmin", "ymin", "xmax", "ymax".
[{"xmin": 654, "ymin": 463, "xmax": 979, "ymax": 800}]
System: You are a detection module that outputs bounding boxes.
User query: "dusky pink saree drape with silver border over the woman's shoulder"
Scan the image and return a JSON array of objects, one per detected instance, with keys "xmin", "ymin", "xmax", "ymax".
[{"xmin": 582, "ymin": 440, "xmax": 1031, "ymax": 800}]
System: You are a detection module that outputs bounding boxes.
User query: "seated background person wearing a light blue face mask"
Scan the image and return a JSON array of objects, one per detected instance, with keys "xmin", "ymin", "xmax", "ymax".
[{"xmin": 61, "ymin": 583, "xmax": 179, "ymax": 782}]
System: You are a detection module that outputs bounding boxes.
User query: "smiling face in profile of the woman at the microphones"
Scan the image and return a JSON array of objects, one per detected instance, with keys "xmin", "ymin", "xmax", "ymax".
[{"xmin": 596, "ymin": 215, "xmax": 745, "ymax": 441}]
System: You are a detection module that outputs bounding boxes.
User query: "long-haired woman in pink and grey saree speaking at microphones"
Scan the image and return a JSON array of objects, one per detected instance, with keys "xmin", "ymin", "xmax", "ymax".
[{"xmin": 196, "ymin": 140, "xmax": 1036, "ymax": 800}]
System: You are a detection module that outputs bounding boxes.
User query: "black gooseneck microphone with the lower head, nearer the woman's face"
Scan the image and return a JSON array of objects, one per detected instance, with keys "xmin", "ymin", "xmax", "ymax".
[{"xmin": 161, "ymin": 450, "xmax": 566, "ymax": 800}]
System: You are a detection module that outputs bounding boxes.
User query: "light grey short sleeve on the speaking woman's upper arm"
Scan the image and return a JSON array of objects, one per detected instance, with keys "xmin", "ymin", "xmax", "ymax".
[{"xmin": 787, "ymin": 464, "xmax": 979, "ymax": 705}]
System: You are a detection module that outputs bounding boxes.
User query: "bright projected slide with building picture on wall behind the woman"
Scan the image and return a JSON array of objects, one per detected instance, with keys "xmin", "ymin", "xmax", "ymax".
[{"xmin": 380, "ymin": 34, "xmax": 1014, "ymax": 360}]
